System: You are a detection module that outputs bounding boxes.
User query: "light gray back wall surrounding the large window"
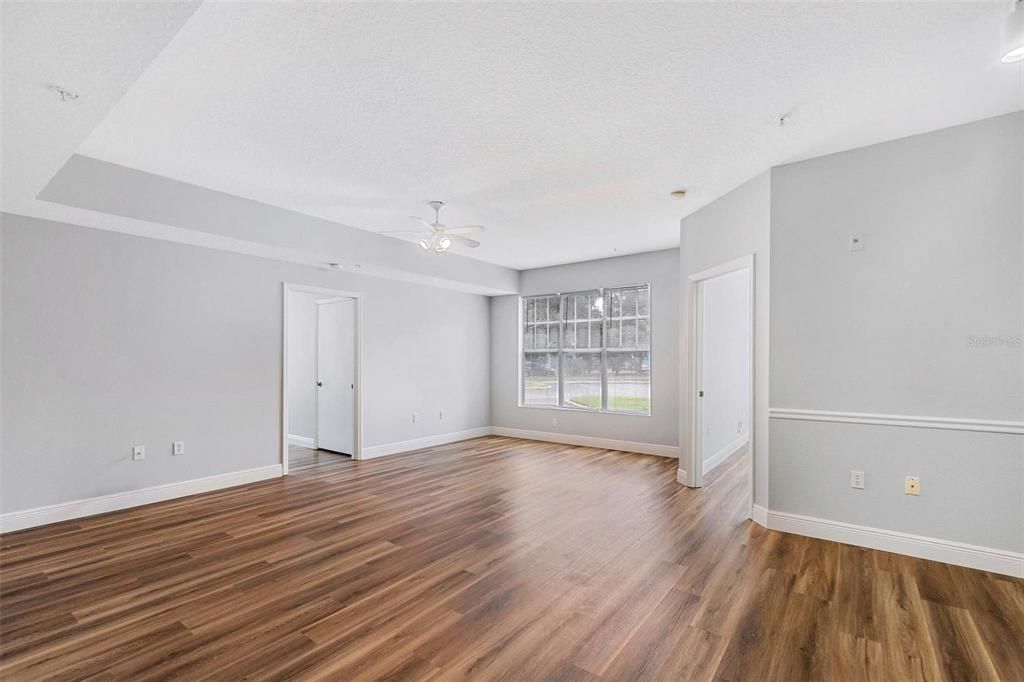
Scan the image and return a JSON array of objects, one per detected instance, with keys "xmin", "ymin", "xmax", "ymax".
[{"xmin": 490, "ymin": 249, "xmax": 679, "ymax": 446}]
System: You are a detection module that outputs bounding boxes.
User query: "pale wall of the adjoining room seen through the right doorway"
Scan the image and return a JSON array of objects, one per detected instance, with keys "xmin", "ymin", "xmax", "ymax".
[{"xmin": 700, "ymin": 270, "xmax": 751, "ymax": 473}]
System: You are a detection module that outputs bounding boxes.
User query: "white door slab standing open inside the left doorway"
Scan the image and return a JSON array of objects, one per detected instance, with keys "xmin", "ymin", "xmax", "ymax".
[{"xmin": 316, "ymin": 298, "xmax": 355, "ymax": 455}]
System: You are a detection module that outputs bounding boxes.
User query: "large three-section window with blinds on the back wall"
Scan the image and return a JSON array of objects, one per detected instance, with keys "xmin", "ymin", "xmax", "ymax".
[{"xmin": 520, "ymin": 285, "xmax": 650, "ymax": 415}]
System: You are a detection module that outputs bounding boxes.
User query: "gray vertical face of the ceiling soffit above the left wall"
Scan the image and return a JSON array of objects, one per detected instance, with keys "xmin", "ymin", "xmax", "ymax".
[{"xmin": 39, "ymin": 154, "xmax": 519, "ymax": 294}]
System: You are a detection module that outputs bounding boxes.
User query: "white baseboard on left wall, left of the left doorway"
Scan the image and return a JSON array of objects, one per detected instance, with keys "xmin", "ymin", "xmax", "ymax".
[{"xmin": 0, "ymin": 464, "xmax": 282, "ymax": 532}]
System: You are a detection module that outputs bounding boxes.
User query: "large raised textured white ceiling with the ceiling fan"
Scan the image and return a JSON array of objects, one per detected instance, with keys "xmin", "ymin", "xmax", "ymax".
[{"xmin": 28, "ymin": 2, "xmax": 1024, "ymax": 268}]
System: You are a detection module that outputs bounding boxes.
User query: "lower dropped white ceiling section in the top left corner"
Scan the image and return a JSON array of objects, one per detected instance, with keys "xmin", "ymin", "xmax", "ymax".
[{"xmin": 0, "ymin": 1, "xmax": 199, "ymax": 212}]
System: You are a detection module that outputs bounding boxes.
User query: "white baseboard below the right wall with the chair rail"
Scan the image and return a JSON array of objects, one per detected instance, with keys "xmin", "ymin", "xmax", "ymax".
[{"xmin": 754, "ymin": 506, "xmax": 1024, "ymax": 578}]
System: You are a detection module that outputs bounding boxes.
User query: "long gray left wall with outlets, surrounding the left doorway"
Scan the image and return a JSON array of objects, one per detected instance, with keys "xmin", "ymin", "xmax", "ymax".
[{"xmin": 0, "ymin": 214, "xmax": 490, "ymax": 512}]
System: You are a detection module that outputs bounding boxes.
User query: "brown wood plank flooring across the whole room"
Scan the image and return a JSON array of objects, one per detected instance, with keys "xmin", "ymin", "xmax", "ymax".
[{"xmin": 0, "ymin": 437, "xmax": 1024, "ymax": 681}]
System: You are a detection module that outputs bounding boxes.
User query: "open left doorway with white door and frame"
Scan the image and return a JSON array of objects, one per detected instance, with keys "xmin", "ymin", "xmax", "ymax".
[{"xmin": 282, "ymin": 284, "xmax": 361, "ymax": 473}]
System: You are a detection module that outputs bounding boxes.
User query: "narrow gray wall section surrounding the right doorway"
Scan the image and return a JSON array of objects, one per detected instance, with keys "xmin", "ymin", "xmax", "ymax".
[{"xmin": 679, "ymin": 172, "xmax": 771, "ymax": 505}]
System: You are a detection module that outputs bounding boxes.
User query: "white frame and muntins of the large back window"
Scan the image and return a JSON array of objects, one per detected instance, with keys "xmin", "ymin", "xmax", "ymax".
[{"xmin": 517, "ymin": 282, "xmax": 654, "ymax": 417}]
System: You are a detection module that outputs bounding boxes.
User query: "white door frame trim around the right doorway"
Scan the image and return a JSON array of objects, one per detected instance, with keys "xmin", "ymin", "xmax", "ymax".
[{"xmin": 686, "ymin": 253, "xmax": 758, "ymax": 518}]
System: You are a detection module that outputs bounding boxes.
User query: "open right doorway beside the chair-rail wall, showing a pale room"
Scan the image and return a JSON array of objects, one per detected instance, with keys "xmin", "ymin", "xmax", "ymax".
[{"xmin": 688, "ymin": 256, "xmax": 754, "ymax": 516}]
